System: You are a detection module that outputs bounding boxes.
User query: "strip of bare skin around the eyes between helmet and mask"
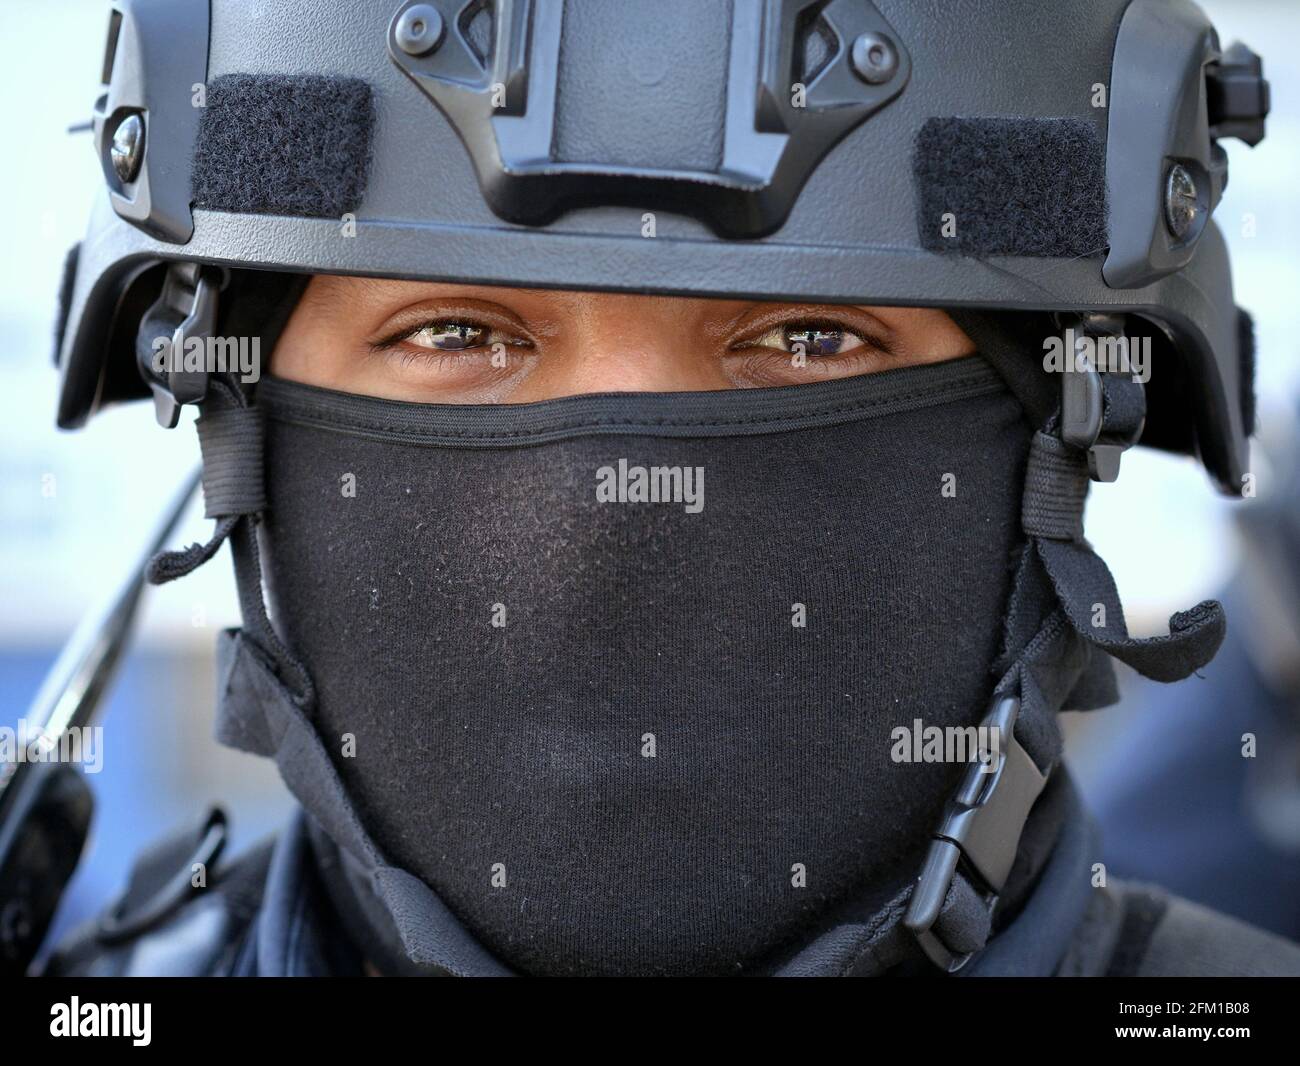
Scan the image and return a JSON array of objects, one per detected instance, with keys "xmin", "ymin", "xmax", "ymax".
[{"xmin": 270, "ymin": 274, "xmax": 974, "ymax": 403}]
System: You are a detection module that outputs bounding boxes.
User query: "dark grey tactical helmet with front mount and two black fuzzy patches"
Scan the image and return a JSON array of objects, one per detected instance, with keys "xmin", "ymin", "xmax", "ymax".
[{"xmin": 59, "ymin": 0, "xmax": 1268, "ymax": 493}]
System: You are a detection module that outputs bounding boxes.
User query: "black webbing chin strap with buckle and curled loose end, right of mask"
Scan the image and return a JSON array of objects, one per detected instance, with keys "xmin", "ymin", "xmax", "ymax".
[{"xmin": 905, "ymin": 361, "xmax": 1225, "ymax": 971}]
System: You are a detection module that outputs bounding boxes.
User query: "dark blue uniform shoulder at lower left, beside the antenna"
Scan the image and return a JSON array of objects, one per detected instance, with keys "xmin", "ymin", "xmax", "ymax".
[{"xmin": 43, "ymin": 811, "xmax": 274, "ymax": 976}]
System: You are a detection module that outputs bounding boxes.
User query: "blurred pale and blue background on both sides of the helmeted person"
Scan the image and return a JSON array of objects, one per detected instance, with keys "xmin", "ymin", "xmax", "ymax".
[{"xmin": 0, "ymin": 0, "xmax": 1300, "ymax": 951}]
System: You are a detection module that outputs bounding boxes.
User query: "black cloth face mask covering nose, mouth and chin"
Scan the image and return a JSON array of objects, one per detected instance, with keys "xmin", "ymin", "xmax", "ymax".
[{"xmin": 248, "ymin": 358, "xmax": 1031, "ymax": 974}]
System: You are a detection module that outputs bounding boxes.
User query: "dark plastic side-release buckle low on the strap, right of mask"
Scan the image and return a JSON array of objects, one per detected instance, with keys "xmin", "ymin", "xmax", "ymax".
[{"xmin": 902, "ymin": 696, "xmax": 1048, "ymax": 972}]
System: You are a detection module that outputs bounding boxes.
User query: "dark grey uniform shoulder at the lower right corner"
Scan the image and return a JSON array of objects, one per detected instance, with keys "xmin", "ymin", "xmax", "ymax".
[{"xmin": 1109, "ymin": 884, "xmax": 1300, "ymax": 978}]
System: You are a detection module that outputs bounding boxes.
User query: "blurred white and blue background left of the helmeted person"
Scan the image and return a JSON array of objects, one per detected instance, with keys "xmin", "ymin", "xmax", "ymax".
[{"xmin": 0, "ymin": 0, "xmax": 290, "ymax": 936}]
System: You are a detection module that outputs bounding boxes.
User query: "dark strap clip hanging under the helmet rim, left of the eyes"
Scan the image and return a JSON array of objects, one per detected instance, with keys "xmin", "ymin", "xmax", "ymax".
[{"xmin": 135, "ymin": 263, "xmax": 221, "ymax": 429}]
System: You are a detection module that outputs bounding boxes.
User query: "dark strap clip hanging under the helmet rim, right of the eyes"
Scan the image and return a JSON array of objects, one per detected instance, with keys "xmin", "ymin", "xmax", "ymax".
[{"xmin": 1061, "ymin": 315, "xmax": 1147, "ymax": 481}]
